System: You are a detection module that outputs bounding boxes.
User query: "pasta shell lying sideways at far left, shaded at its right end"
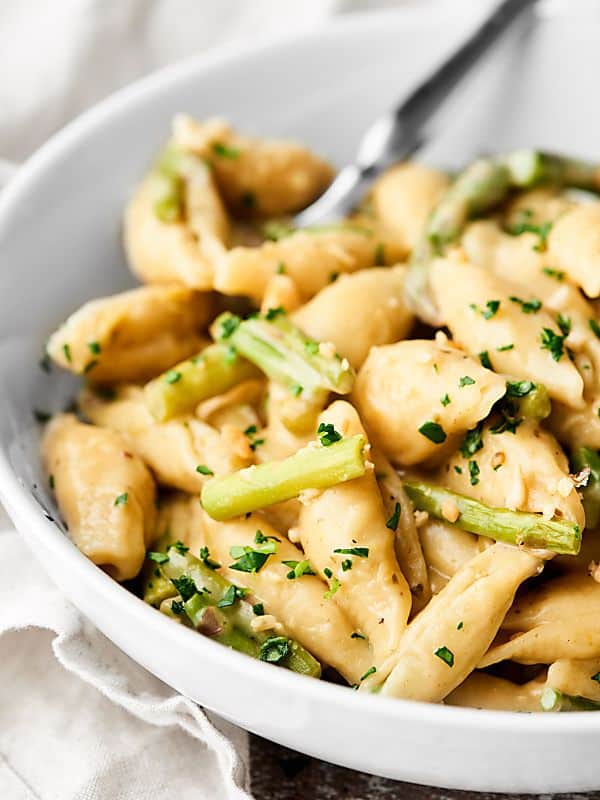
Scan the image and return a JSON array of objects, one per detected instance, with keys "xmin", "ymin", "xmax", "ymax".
[{"xmin": 47, "ymin": 285, "xmax": 213, "ymax": 383}]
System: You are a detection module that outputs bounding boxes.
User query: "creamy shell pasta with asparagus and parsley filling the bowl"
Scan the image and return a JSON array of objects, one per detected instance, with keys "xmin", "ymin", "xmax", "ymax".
[{"xmin": 42, "ymin": 116, "xmax": 600, "ymax": 711}]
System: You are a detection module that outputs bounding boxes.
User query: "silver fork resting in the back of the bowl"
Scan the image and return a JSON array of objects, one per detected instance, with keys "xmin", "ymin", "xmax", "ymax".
[{"xmin": 294, "ymin": 0, "xmax": 536, "ymax": 228}]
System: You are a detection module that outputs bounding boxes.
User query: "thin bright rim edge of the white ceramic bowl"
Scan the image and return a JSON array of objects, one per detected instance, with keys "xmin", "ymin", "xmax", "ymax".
[{"xmin": 0, "ymin": 0, "xmax": 600, "ymax": 736}]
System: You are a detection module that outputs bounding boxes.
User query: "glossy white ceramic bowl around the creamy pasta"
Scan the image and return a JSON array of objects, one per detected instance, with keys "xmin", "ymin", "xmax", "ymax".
[{"xmin": 0, "ymin": 6, "xmax": 600, "ymax": 791}]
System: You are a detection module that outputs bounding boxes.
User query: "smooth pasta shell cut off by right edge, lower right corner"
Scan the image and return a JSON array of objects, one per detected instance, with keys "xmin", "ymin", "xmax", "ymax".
[{"xmin": 479, "ymin": 574, "xmax": 600, "ymax": 667}]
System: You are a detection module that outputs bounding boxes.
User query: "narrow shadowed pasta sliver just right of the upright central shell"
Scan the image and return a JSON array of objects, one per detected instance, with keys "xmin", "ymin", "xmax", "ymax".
[{"xmin": 371, "ymin": 449, "xmax": 431, "ymax": 613}]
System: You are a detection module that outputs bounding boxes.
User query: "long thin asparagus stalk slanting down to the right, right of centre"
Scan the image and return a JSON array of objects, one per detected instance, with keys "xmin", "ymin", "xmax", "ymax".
[{"xmin": 404, "ymin": 481, "xmax": 581, "ymax": 555}]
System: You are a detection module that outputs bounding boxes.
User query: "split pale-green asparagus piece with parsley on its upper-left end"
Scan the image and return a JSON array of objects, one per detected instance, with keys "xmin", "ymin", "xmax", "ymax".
[{"xmin": 212, "ymin": 309, "xmax": 354, "ymax": 400}]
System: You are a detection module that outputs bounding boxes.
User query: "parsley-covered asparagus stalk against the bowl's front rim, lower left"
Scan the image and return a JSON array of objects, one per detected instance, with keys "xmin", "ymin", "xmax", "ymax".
[{"xmin": 154, "ymin": 547, "xmax": 321, "ymax": 678}]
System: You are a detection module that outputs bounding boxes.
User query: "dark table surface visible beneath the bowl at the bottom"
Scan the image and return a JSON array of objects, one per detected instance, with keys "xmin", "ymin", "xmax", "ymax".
[{"xmin": 250, "ymin": 736, "xmax": 600, "ymax": 800}]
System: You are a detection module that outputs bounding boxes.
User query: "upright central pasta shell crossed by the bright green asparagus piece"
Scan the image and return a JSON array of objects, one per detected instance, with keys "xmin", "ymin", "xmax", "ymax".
[{"xmin": 298, "ymin": 400, "xmax": 411, "ymax": 663}]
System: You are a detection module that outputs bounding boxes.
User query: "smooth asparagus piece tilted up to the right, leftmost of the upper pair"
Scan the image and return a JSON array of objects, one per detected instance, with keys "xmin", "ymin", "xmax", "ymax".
[{"xmin": 144, "ymin": 343, "xmax": 260, "ymax": 422}]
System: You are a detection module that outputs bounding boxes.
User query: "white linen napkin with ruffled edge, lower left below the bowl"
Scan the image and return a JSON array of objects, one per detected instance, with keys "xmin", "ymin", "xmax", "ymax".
[{"xmin": 0, "ymin": 530, "xmax": 250, "ymax": 800}]
